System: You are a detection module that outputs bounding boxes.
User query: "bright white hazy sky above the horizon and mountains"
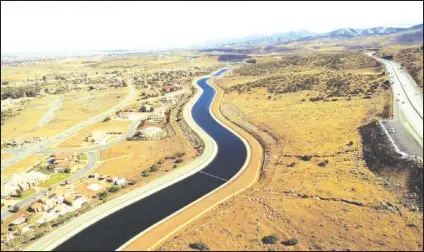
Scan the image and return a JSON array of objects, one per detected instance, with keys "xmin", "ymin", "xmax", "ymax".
[{"xmin": 1, "ymin": 1, "xmax": 423, "ymax": 53}]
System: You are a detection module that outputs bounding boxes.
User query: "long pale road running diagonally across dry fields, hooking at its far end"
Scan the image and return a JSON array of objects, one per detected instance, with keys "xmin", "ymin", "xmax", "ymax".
[{"xmin": 1, "ymin": 83, "xmax": 136, "ymax": 169}]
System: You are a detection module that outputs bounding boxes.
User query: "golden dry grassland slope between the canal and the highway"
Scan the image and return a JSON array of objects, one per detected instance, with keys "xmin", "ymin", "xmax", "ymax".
[{"xmin": 161, "ymin": 51, "xmax": 423, "ymax": 251}]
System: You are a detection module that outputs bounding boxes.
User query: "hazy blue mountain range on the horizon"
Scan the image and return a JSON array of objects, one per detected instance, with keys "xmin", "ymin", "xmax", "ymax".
[{"xmin": 210, "ymin": 24, "xmax": 423, "ymax": 48}]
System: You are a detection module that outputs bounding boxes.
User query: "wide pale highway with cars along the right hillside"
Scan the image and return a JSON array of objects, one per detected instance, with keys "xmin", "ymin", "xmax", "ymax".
[{"xmin": 368, "ymin": 54, "xmax": 423, "ymax": 154}]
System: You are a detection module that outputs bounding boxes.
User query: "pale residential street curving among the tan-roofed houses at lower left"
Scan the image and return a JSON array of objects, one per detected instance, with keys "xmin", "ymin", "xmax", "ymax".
[{"xmin": 1, "ymin": 152, "xmax": 97, "ymax": 220}]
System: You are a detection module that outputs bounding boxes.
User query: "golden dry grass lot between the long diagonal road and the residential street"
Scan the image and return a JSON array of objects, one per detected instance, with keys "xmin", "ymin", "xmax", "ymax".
[{"xmin": 55, "ymin": 120, "xmax": 131, "ymax": 148}]
